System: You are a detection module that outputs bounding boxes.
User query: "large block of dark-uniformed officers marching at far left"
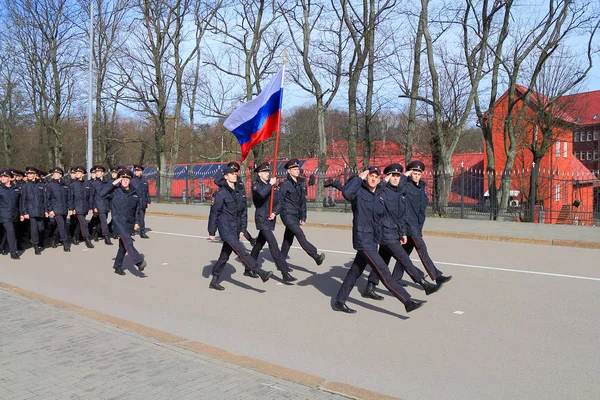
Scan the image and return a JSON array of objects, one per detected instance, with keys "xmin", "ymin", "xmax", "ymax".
[{"xmin": 0, "ymin": 165, "xmax": 150, "ymax": 275}]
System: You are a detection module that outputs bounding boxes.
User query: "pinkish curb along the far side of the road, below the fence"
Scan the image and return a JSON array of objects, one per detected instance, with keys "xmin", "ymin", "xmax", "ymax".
[{"xmin": 146, "ymin": 211, "xmax": 600, "ymax": 250}]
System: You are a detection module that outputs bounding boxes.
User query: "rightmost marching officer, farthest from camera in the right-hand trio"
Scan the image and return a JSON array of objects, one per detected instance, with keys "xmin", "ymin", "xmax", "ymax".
[{"xmin": 400, "ymin": 161, "xmax": 452, "ymax": 285}]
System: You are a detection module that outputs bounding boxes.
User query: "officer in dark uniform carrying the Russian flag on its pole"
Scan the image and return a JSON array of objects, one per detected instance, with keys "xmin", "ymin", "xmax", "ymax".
[{"xmin": 244, "ymin": 161, "xmax": 296, "ymax": 283}]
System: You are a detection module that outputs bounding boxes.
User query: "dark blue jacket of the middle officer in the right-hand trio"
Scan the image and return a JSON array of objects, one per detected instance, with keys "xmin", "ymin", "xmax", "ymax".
[{"xmin": 379, "ymin": 182, "xmax": 406, "ymax": 245}]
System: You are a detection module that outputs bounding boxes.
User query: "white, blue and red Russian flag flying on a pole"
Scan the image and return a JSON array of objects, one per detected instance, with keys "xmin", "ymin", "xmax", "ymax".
[{"xmin": 223, "ymin": 64, "xmax": 285, "ymax": 161}]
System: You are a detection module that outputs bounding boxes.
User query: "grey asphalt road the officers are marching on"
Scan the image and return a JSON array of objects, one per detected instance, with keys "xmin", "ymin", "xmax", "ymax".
[{"xmin": 0, "ymin": 217, "xmax": 600, "ymax": 400}]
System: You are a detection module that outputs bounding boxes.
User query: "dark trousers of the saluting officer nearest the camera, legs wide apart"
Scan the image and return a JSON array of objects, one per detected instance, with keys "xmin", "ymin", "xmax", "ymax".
[{"xmin": 336, "ymin": 250, "xmax": 410, "ymax": 303}]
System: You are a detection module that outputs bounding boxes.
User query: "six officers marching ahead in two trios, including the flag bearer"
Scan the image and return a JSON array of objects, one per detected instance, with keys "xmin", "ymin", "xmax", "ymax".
[{"xmin": 208, "ymin": 159, "xmax": 452, "ymax": 314}]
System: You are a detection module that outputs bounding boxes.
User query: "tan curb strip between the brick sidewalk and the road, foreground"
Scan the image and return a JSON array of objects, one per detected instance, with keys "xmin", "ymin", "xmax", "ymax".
[{"xmin": 0, "ymin": 282, "xmax": 402, "ymax": 400}]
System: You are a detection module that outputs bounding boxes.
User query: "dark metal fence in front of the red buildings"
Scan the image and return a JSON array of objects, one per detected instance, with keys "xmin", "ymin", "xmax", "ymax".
[{"xmin": 146, "ymin": 167, "xmax": 600, "ymax": 226}]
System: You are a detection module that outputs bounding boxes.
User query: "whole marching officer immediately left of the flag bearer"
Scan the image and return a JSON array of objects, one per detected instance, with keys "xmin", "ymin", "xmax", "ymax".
[{"xmin": 208, "ymin": 167, "xmax": 273, "ymax": 290}]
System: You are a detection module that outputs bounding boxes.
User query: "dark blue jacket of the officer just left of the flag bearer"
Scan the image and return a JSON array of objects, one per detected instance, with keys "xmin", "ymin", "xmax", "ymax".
[{"xmin": 208, "ymin": 185, "xmax": 248, "ymax": 240}]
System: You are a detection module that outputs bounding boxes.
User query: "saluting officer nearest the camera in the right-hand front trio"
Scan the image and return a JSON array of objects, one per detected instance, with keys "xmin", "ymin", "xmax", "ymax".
[{"xmin": 333, "ymin": 167, "xmax": 423, "ymax": 314}]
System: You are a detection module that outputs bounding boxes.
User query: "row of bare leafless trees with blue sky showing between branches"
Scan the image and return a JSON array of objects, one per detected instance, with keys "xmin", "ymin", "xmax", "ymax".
[{"xmin": 0, "ymin": 0, "xmax": 598, "ymax": 209}]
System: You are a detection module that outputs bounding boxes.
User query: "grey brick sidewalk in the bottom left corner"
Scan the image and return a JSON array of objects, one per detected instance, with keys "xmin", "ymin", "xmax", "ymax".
[{"xmin": 0, "ymin": 290, "xmax": 347, "ymax": 400}]
